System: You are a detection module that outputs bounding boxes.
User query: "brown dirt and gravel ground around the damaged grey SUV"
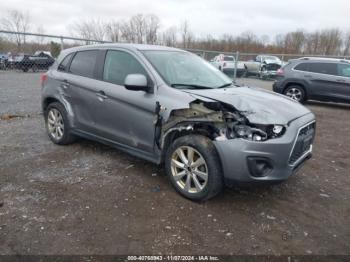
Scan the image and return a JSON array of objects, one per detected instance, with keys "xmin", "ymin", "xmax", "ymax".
[{"xmin": 0, "ymin": 72, "xmax": 350, "ymax": 254}]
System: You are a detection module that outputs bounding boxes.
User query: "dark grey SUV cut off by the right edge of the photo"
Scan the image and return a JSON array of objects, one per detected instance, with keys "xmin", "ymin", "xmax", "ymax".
[{"xmin": 273, "ymin": 57, "xmax": 350, "ymax": 103}]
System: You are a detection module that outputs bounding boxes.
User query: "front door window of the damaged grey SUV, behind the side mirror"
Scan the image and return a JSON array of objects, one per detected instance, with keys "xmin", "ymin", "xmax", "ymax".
[{"xmin": 103, "ymin": 50, "xmax": 147, "ymax": 85}]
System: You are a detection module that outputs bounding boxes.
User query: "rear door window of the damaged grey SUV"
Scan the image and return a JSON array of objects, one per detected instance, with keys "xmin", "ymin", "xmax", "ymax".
[{"xmin": 69, "ymin": 50, "xmax": 98, "ymax": 78}]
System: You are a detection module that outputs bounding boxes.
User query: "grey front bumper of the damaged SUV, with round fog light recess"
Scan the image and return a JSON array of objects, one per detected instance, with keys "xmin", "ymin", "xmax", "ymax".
[{"xmin": 214, "ymin": 113, "xmax": 315, "ymax": 184}]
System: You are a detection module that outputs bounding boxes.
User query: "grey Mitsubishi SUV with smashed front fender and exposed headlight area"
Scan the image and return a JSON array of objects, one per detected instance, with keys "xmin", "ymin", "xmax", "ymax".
[{"xmin": 41, "ymin": 44, "xmax": 315, "ymax": 200}]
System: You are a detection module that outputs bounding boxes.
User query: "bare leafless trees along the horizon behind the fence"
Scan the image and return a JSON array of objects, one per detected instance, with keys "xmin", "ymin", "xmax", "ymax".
[{"xmin": 0, "ymin": 10, "xmax": 350, "ymax": 56}]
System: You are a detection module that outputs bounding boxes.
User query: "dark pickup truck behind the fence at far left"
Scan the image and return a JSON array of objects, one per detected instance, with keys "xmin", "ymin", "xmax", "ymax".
[{"xmin": 14, "ymin": 52, "xmax": 55, "ymax": 72}]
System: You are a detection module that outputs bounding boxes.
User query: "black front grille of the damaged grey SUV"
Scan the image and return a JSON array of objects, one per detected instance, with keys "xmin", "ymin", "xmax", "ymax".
[{"xmin": 288, "ymin": 122, "xmax": 316, "ymax": 165}]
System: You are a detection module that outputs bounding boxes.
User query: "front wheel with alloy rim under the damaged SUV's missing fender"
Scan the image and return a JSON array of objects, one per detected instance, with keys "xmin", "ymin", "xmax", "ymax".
[{"xmin": 165, "ymin": 135, "xmax": 224, "ymax": 201}]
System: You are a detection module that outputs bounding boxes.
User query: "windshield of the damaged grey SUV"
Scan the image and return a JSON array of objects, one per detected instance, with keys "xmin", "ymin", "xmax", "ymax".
[{"xmin": 143, "ymin": 51, "xmax": 232, "ymax": 89}]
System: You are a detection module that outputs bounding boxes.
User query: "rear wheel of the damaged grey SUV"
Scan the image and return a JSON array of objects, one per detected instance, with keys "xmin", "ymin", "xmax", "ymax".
[{"xmin": 44, "ymin": 102, "xmax": 75, "ymax": 145}]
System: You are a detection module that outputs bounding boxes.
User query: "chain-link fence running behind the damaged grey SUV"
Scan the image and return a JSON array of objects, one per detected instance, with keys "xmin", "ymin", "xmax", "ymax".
[{"xmin": 0, "ymin": 31, "xmax": 350, "ymax": 81}]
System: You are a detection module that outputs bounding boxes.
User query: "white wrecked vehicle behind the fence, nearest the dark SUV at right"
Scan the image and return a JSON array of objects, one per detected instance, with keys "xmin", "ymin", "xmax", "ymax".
[{"xmin": 244, "ymin": 55, "xmax": 283, "ymax": 79}]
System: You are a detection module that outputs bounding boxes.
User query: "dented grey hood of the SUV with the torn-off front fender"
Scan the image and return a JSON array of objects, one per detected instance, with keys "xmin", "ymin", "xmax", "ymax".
[{"xmin": 183, "ymin": 87, "xmax": 311, "ymax": 125}]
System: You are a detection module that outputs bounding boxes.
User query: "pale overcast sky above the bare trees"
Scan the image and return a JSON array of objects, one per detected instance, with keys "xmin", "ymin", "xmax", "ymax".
[{"xmin": 0, "ymin": 0, "xmax": 350, "ymax": 37}]
